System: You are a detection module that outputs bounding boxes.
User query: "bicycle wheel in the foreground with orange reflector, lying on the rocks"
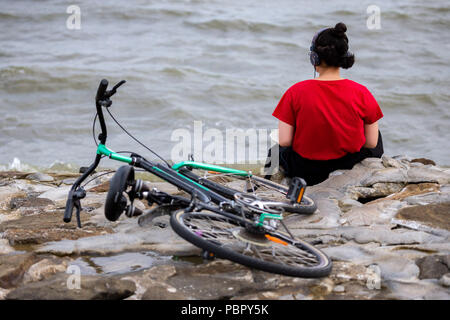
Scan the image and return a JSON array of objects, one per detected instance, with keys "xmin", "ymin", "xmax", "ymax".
[{"xmin": 170, "ymin": 211, "xmax": 332, "ymax": 278}]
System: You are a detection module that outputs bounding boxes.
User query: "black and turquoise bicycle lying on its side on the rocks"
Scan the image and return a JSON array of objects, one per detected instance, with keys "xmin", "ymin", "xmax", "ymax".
[{"xmin": 64, "ymin": 79, "xmax": 332, "ymax": 278}]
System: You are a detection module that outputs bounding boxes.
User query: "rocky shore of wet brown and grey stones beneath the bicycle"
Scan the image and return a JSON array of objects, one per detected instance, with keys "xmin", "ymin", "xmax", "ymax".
[{"xmin": 0, "ymin": 156, "xmax": 450, "ymax": 299}]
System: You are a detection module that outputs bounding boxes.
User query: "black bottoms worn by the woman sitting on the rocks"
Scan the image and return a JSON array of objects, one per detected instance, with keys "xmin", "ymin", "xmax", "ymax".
[{"xmin": 265, "ymin": 132, "xmax": 384, "ymax": 186}]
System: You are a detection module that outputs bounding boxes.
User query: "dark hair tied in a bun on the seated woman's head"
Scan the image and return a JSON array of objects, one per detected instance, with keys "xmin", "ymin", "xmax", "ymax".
[{"xmin": 314, "ymin": 22, "xmax": 355, "ymax": 69}]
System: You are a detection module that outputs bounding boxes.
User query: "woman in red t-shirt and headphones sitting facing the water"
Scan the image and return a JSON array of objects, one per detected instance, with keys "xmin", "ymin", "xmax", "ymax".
[{"xmin": 266, "ymin": 23, "xmax": 383, "ymax": 185}]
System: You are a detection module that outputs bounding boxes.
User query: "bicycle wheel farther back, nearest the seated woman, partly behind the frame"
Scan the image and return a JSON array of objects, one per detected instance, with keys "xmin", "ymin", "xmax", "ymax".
[{"xmin": 180, "ymin": 170, "xmax": 317, "ymax": 214}]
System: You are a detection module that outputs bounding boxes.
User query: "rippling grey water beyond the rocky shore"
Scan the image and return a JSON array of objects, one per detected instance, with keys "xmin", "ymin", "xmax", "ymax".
[{"xmin": 0, "ymin": 0, "xmax": 450, "ymax": 168}]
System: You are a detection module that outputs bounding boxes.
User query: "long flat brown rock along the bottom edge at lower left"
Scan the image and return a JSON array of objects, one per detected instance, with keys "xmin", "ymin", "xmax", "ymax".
[{"xmin": 6, "ymin": 273, "xmax": 136, "ymax": 300}]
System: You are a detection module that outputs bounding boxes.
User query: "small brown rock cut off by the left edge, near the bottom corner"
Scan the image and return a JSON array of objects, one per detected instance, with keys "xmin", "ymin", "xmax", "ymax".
[{"xmin": 0, "ymin": 253, "xmax": 37, "ymax": 289}]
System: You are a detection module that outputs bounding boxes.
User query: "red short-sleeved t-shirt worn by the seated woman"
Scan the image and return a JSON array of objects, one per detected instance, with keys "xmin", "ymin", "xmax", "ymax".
[{"xmin": 272, "ymin": 79, "xmax": 383, "ymax": 160}]
